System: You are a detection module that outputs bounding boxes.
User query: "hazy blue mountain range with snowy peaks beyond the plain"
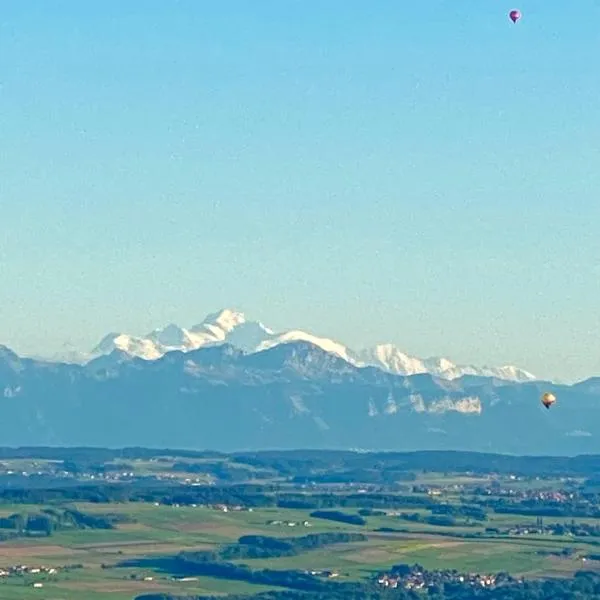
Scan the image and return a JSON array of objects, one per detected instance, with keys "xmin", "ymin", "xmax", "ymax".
[{"xmin": 0, "ymin": 311, "xmax": 600, "ymax": 455}]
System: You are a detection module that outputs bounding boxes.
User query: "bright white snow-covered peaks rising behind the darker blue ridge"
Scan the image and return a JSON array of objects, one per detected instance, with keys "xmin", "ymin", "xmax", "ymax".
[{"xmin": 83, "ymin": 309, "xmax": 536, "ymax": 382}]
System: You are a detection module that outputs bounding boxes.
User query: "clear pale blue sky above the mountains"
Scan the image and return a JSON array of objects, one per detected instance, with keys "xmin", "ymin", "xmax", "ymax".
[{"xmin": 0, "ymin": 0, "xmax": 600, "ymax": 379}]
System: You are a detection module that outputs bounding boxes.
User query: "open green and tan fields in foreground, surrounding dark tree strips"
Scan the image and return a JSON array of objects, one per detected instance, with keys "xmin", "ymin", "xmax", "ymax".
[{"xmin": 0, "ymin": 504, "xmax": 594, "ymax": 600}]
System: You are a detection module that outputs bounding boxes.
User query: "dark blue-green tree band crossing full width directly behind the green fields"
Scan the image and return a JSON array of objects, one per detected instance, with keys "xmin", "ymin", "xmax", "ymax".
[{"xmin": 0, "ymin": 479, "xmax": 600, "ymax": 525}]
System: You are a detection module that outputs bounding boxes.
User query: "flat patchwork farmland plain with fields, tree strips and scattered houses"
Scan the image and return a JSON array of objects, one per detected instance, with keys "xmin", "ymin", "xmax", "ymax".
[{"xmin": 0, "ymin": 449, "xmax": 600, "ymax": 600}]
